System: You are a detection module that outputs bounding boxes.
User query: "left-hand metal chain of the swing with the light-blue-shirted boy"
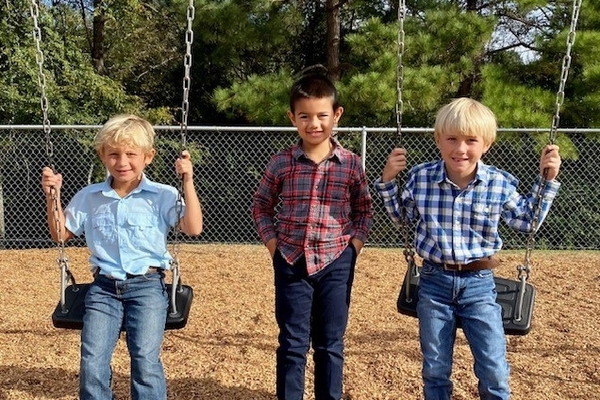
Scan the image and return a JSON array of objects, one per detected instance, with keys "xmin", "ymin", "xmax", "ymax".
[{"xmin": 29, "ymin": 0, "xmax": 75, "ymax": 313}]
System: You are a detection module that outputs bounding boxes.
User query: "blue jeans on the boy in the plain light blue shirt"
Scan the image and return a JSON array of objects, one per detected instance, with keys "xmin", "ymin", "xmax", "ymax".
[{"xmin": 79, "ymin": 272, "xmax": 169, "ymax": 400}]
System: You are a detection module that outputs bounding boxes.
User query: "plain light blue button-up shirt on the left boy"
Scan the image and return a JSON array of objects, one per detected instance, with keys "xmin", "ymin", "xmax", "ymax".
[{"xmin": 64, "ymin": 175, "xmax": 185, "ymax": 279}]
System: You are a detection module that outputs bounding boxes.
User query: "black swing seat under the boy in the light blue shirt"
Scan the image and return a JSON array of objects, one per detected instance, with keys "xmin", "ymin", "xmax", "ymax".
[{"xmin": 52, "ymin": 283, "xmax": 194, "ymax": 331}]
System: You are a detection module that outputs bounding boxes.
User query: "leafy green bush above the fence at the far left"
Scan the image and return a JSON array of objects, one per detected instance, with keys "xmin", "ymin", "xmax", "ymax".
[{"xmin": 0, "ymin": 3, "xmax": 143, "ymax": 124}]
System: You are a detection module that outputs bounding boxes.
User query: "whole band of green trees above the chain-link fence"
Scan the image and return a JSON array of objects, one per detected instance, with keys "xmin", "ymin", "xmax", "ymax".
[{"xmin": 0, "ymin": 0, "xmax": 600, "ymax": 131}]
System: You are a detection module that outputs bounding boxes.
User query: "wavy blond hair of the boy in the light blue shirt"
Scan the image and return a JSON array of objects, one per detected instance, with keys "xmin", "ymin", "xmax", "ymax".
[{"xmin": 94, "ymin": 114, "xmax": 155, "ymax": 155}]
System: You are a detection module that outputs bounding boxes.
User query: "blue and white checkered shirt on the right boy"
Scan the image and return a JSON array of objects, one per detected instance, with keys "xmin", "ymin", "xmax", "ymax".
[{"xmin": 374, "ymin": 160, "xmax": 560, "ymax": 264}]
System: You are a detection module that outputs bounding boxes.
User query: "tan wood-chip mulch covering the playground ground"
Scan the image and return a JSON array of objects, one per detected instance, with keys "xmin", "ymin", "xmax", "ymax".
[{"xmin": 0, "ymin": 245, "xmax": 600, "ymax": 400}]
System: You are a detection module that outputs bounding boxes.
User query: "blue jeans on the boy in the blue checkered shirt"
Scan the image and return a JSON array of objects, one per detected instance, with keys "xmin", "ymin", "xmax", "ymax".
[{"xmin": 417, "ymin": 261, "xmax": 510, "ymax": 400}]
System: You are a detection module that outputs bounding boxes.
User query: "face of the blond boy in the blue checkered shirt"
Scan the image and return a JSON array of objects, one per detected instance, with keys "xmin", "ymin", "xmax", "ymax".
[{"xmin": 436, "ymin": 133, "xmax": 490, "ymax": 184}]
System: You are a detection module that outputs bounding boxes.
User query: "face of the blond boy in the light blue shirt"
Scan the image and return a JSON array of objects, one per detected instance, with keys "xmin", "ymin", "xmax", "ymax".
[{"xmin": 100, "ymin": 145, "xmax": 155, "ymax": 189}]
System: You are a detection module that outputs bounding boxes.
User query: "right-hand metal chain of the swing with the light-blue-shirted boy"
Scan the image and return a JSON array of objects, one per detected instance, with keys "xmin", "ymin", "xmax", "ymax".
[{"xmin": 171, "ymin": 0, "xmax": 195, "ymax": 315}]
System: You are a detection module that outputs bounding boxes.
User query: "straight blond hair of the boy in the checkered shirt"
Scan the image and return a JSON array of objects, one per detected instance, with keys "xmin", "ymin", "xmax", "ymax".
[{"xmin": 433, "ymin": 97, "xmax": 498, "ymax": 145}]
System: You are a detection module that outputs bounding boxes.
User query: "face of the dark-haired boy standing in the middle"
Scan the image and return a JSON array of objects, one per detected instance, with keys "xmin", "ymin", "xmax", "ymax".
[{"xmin": 288, "ymin": 97, "xmax": 344, "ymax": 148}]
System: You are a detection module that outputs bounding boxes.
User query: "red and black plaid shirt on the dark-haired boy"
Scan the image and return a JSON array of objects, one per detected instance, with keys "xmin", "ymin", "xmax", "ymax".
[{"xmin": 252, "ymin": 141, "xmax": 373, "ymax": 275}]
